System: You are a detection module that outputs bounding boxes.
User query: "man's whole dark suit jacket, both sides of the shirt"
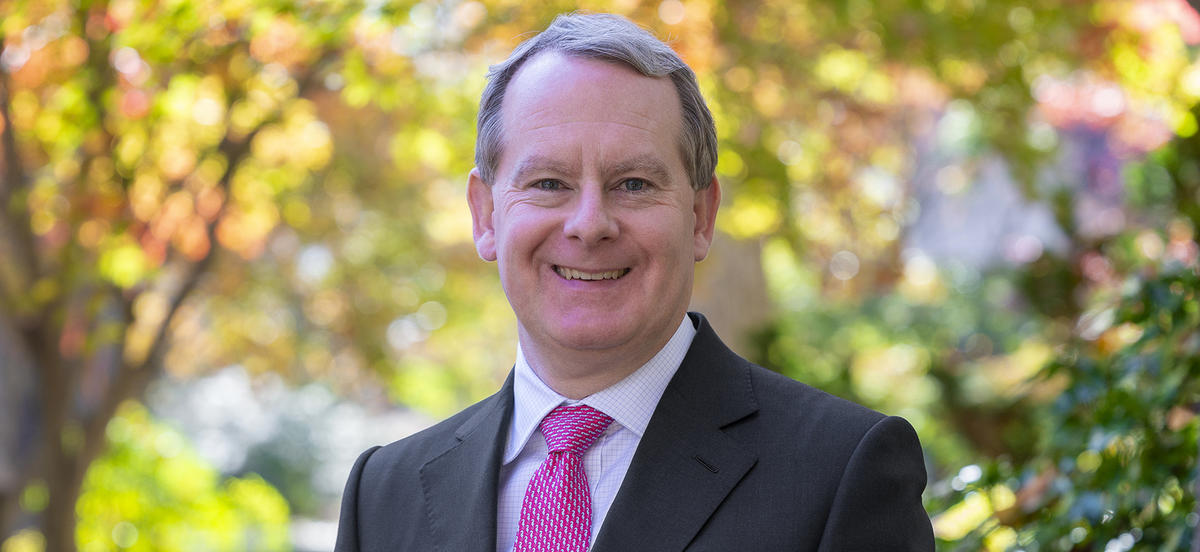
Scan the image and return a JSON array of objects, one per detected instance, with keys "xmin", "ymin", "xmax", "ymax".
[{"xmin": 336, "ymin": 313, "xmax": 934, "ymax": 552}]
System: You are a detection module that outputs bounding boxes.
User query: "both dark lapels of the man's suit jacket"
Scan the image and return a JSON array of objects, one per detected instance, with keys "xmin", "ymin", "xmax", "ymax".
[{"xmin": 420, "ymin": 312, "xmax": 758, "ymax": 552}]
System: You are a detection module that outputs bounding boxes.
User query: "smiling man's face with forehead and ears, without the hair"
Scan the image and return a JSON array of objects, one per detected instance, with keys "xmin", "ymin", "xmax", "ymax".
[{"xmin": 468, "ymin": 53, "xmax": 720, "ymax": 361}]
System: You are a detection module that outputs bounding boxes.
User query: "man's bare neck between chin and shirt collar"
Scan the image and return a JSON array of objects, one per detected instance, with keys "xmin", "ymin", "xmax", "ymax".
[{"xmin": 517, "ymin": 316, "xmax": 678, "ymax": 400}]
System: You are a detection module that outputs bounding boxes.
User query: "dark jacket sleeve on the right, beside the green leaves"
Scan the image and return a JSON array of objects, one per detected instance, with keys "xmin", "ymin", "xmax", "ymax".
[{"xmin": 820, "ymin": 416, "xmax": 934, "ymax": 552}]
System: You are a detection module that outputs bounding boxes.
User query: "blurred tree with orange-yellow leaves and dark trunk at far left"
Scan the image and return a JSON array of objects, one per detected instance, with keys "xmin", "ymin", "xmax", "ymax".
[{"xmin": 0, "ymin": 1, "xmax": 360, "ymax": 542}]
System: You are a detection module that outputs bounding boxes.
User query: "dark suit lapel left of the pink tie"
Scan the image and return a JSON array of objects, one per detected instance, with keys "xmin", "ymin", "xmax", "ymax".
[{"xmin": 421, "ymin": 372, "xmax": 512, "ymax": 552}]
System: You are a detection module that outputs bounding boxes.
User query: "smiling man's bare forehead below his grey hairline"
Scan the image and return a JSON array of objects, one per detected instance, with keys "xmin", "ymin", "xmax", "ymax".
[{"xmin": 502, "ymin": 52, "xmax": 683, "ymax": 174}]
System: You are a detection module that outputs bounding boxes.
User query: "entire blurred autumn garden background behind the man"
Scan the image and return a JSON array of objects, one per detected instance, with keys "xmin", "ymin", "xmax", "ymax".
[{"xmin": 0, "ymin": 0, "xmax": 1200, "ymax": 552}]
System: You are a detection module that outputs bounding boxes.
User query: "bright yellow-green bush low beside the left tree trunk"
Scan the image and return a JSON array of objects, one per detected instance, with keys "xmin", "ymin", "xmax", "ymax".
[{"xmin": 74, "ymin": 403, "xmax": 290, "ymax": 552}]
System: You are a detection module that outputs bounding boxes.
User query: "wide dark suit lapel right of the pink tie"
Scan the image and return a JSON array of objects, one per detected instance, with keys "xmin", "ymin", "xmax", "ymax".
[{"xmin": 593, "ymin": 314, "xmax": 757, "ymax": 552}]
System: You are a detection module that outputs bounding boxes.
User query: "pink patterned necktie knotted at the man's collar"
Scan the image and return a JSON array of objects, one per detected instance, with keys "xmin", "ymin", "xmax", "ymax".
[{"xmin": 512, "ymin": 404, "xmax": 612, "ymax": 552}]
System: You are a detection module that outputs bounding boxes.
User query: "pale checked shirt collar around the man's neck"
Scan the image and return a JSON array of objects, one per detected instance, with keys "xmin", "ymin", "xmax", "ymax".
[{"xmin": 504, "ymin": 314, "xmax": 696, "ymax": 464}]
